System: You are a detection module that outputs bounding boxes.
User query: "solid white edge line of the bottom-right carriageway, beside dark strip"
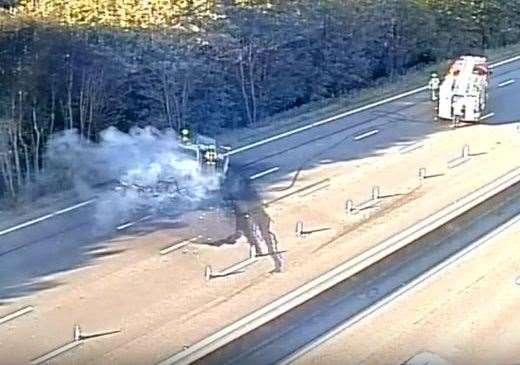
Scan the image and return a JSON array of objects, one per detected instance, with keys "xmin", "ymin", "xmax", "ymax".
[{"xmin": 277, "ymin": 215, "xmax": 520, "ymax": 365}]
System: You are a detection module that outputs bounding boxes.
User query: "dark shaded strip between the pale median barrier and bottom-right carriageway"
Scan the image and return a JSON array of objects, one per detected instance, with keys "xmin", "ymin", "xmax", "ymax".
[{"xmin": 196, "ymin": 178, "xmax": 520, "ymax": 365}]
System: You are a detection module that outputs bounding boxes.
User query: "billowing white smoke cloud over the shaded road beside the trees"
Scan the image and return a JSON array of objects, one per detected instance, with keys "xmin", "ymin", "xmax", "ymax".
[{"xmin": 47, "ymin": 127, "xmax": 219, "ymax": 228}]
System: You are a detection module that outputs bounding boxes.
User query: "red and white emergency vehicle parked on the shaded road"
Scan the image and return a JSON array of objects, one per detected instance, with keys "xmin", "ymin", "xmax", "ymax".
[{"xmin": 438, "ymin": 56, "xmax": 489, "ymax": 124}]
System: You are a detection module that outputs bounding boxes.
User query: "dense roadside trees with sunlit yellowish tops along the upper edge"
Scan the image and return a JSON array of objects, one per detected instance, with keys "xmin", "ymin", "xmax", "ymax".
[{"xmin": 0, "ymin": 0, "xmax": 520, "ymax": 196}]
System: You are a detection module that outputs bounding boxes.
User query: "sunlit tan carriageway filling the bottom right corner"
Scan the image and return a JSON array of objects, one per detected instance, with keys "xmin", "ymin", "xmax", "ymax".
[{"xmin": 294, "ymin": 210, "xmax": 520, "ymax": 365}]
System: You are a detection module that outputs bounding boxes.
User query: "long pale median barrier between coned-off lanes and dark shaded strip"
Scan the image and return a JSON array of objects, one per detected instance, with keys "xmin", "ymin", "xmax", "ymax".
[{"xmin": 159, "ymin": 167, "xmax": 520, "ymax": 365}]
